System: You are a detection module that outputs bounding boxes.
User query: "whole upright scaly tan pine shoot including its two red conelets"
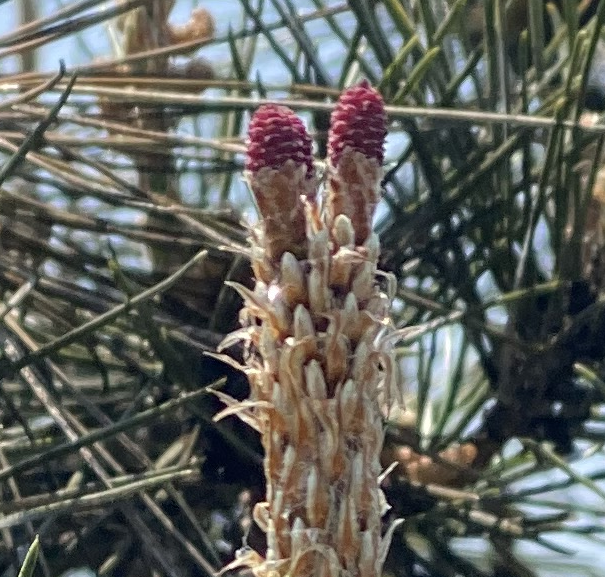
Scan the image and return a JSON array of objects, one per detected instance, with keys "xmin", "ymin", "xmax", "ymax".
[{"xmin": 221, "ymin": 85, "xmax": 400, "ymax": 577}]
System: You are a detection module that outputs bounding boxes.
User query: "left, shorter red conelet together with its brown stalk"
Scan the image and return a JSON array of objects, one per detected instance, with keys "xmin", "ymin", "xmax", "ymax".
[{"xmin": 245, "ymin": 104, "xmax": 315, "ymax": 268}]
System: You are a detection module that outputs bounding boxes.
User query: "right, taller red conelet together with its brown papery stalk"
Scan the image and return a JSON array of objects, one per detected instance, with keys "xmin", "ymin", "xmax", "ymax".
[{"xmin": 326, "ymin": 81, "xmax": 387, "ymax": 244}]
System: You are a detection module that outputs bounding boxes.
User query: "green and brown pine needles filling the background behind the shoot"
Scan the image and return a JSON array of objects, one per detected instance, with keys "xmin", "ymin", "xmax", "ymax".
[{"xmin": 0, "ymin": 0, "xmax": 605, "ymax": 577}]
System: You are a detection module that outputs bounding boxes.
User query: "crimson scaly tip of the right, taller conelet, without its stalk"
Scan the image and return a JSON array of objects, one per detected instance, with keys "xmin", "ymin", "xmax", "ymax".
[{"xmin": 328, "ymin": 80, "xmax": 387, "ymax": 166}]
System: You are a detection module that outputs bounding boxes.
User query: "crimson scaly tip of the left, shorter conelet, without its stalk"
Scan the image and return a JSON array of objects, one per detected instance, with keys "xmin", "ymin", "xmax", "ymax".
[{"xmin": 246, "ymin": 104, "xmax": 314, "ymax": 178}]
